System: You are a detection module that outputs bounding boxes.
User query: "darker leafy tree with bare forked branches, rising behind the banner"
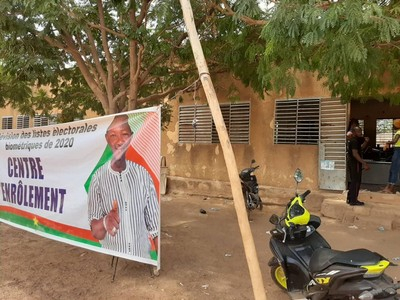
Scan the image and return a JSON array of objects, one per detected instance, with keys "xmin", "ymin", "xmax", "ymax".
[{"xmin": 0, "ymin": 0, "xmax": 276, "ymax": 121}]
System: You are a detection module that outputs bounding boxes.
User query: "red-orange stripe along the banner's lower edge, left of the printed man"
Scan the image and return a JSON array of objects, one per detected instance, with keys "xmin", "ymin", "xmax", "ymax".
[{"xmin": 0, "ymin": 205, "xmax": 98, "ymax": 242}]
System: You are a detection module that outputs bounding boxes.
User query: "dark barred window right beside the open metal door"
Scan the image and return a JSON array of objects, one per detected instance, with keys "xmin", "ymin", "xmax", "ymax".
[{"xmin": 274, "ymin": 99, "xmax": 320, "ymax": 145}]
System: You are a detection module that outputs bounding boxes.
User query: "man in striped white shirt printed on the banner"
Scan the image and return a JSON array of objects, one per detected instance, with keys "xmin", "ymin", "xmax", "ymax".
[{"xmin": 88, "ymin": 115, "xmax": 160, "ymax": 259}]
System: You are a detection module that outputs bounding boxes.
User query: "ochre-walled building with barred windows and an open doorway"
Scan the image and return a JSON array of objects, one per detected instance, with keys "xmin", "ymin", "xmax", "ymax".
[{"xmin": 162, "ymin": 74, "xmax": 400, "ymax": 190}]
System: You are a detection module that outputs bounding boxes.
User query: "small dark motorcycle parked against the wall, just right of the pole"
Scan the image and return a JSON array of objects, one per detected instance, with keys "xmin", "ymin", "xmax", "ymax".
[{"xmin": 239, "ymin": 159, "xmax": 263, "ymax": 218}]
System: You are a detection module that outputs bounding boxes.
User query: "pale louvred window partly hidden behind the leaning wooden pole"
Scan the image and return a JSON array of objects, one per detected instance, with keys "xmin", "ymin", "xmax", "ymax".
[{"xmin": 179, "ymin": 102, "xmax": 250, "ymax": 144}]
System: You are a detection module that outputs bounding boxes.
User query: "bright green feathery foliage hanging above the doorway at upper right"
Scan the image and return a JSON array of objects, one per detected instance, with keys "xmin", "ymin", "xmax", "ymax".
[{"xmin": 259, "ymin": 0, "xmax": 400, "ymax": 104}]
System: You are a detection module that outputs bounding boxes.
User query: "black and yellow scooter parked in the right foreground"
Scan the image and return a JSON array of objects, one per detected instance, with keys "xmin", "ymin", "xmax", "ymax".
[{"xmin": 268, "ymin": 169, "xmax": 400, "ymax": 300}]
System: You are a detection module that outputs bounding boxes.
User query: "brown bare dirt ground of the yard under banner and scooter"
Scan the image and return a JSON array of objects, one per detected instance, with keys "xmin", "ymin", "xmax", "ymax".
[{"xmin": 0, "ymin": 194, "xmax": 400, "ymax": 300}]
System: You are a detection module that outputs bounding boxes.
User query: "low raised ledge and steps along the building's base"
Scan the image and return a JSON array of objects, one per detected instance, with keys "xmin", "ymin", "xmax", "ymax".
[{"xmin": 167, "ymin": 177, "xmax": 400, "ymax": 230}]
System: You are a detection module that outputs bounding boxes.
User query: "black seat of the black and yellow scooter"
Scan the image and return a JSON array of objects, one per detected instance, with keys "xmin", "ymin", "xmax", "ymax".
[{"xmin": 309, "ymin": 248, "xmax": 382, "ymax": 274}]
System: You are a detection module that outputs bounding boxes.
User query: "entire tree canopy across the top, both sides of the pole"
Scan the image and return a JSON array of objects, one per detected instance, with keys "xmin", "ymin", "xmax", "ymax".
[{"xmin": 4, "ymin": 0, "xmax": 400, "ymax": 121}]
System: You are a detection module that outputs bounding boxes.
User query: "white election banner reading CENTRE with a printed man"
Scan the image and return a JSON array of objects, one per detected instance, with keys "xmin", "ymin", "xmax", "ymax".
[{"xmin": 0, "ymin": 107, "xmax": 161, "ymax": 268}]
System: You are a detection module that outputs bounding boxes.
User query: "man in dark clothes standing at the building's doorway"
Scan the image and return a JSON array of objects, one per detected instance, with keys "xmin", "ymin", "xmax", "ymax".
[{"xmin": 347, "ymin": 126, "xmax": 369, "ymax": 205}]
